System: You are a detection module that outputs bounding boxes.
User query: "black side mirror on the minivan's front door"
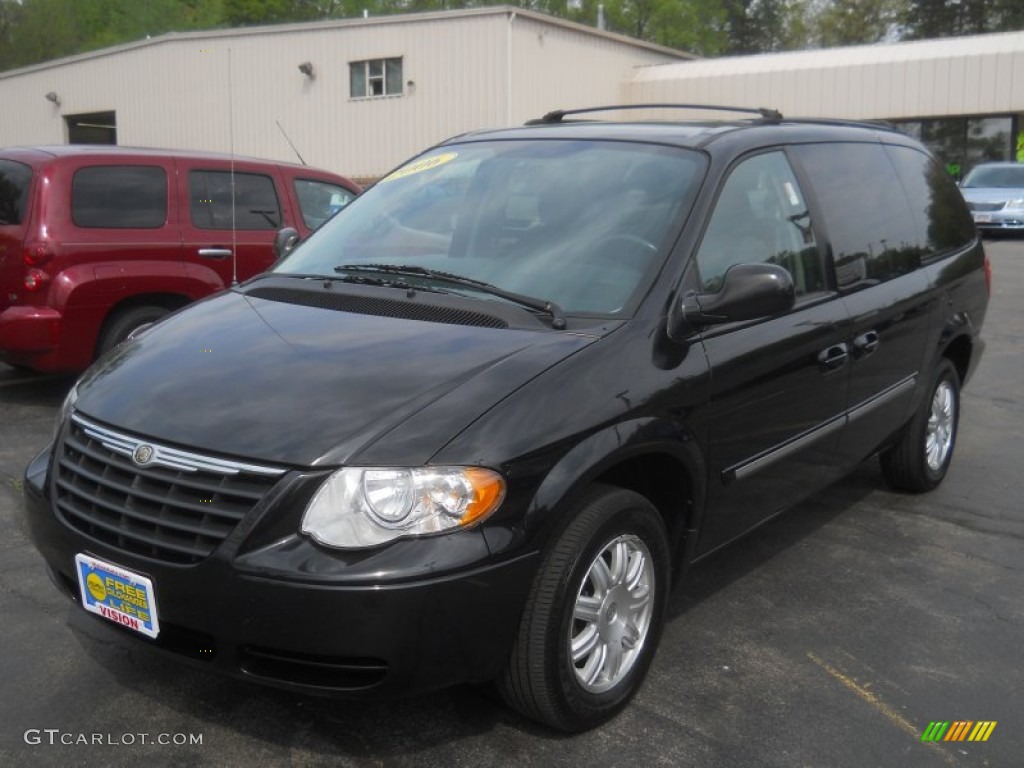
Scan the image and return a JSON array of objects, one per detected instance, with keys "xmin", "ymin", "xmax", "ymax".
[{"xmin": 670, "ymin": 263, "xmax": 797, "ymax": 336}]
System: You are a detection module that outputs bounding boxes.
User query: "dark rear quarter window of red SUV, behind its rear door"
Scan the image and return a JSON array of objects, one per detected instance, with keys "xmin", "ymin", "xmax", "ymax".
[{"xmin": 71, "ymin": 165, "xmax": 167, "ymax": 229}]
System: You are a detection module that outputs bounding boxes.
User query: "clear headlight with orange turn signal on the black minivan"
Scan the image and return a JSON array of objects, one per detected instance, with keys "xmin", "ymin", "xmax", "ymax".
[{"xmin": 302, "ymin": 467, "xmax": 505, "ymax": 549}]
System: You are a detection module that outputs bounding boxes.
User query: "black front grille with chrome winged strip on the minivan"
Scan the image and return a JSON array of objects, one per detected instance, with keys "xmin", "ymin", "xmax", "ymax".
[{"xmin": 53, "ymin": 415, "xmax": 285, "ymax": 564}]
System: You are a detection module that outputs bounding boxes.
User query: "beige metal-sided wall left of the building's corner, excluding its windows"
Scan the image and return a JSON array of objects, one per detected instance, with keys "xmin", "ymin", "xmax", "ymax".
[{"xmin": 0, "ymin": 15, "xmax": 512, "ymax": 177}]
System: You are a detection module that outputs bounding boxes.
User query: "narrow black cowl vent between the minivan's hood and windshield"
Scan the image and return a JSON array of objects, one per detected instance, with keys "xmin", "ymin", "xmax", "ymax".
[{"xmin": 246, "ymin": 286, "xmax": 509, "ymax": 328}]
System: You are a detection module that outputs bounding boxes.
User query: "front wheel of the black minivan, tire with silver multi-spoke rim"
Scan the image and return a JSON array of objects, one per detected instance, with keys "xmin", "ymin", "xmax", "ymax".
[{"xmin": 497, "ymin": 485, "xmax": 670, "ymax": 731}]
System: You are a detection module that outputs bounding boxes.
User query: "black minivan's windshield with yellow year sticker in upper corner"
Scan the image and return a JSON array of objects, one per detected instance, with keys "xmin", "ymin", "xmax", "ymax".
[{"xmin": 273, "ymin": 139, "xmax": 705, "ymax": 314}]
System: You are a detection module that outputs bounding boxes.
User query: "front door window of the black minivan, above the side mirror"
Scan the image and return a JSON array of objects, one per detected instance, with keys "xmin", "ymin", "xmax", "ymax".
[{"xmin": 696, "ymin": 152, "xmax": 824, "ymax": 297}]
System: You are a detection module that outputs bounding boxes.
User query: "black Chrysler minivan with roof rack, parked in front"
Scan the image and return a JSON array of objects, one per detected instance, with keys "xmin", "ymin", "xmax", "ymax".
[{"xmin": 25, "ymin": 111, "xmax": 990, "ymax": 730}]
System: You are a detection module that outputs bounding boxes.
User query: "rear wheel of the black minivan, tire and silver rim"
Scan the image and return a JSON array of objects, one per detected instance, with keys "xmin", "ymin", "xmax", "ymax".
[{"xmin": 880, "ymin": 357, "xmax": 961, "ymax": 494}]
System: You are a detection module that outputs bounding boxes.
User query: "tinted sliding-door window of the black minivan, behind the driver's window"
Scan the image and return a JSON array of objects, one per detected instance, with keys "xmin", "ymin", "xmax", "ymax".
[{"xmin": 795, "ymin": 143, "xmax": 926, "ymax": 289}]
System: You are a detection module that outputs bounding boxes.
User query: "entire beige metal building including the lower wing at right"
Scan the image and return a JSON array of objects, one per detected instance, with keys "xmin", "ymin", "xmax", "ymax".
[{"xmin": 0, "ymin": 6, "xmax": 1024, "ymax": 179}]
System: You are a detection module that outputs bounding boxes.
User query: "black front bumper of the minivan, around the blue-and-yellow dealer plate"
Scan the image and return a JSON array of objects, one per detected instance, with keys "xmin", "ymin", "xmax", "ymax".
[{"xmin": 25, "ymin": 453, "xmax": 537, "ymax": 696}]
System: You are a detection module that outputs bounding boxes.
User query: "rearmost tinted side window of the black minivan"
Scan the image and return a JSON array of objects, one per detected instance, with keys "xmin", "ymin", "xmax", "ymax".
[{"xmin": 886, "ymin": 146, "xmax": 974, "ymax": 256}]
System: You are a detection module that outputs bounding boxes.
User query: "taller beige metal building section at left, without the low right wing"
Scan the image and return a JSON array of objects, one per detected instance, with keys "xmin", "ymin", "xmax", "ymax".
[{"xmin": 0, "ymin": 7, "xmax": 691, "ymax": 178}]
